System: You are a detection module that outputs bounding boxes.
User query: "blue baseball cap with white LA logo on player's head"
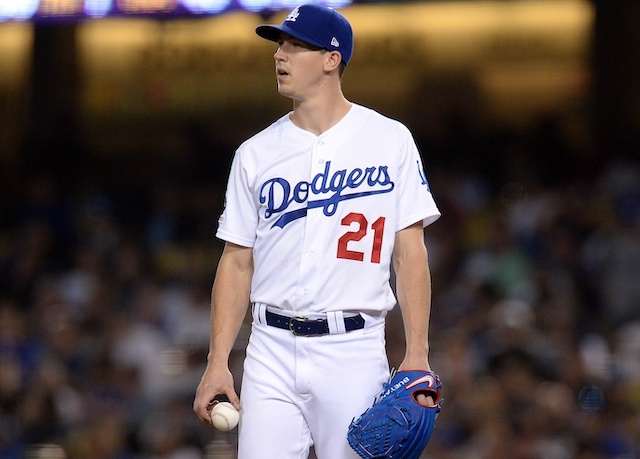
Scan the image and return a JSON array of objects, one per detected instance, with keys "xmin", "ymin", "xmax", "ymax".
[{"xmin": 256, "ymin": 4, "xmax": 353, "ymax": 64}]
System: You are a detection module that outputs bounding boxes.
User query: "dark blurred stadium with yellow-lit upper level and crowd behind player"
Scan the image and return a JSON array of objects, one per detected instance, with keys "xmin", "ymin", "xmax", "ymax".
[{"xmin": 0, "ymin": 0, "xmax": 640, "ymax": 459}]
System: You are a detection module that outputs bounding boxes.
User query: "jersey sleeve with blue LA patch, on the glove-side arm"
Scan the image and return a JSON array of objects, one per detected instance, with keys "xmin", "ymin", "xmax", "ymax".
[{"xmin": 396, "ymin": 128, "xmax": 440, "ymax": 231}]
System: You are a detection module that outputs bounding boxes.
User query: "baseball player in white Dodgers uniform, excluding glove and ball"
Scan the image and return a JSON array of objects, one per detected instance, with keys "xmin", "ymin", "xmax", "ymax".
[{"xmin": 193, "ymin": 5, "xmax": 440, "ymax": 459}]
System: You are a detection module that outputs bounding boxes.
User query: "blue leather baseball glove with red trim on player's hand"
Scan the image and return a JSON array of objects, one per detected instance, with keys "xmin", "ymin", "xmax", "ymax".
[{"xmin": 347, "ymin": 371, "xmax": 442, "ymax": 459}]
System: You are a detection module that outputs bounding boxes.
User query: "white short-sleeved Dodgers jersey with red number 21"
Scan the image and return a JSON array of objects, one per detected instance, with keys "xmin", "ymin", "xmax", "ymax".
[{"xmin": 216, "ymin": 104, "xmax": 440, "ymax": 315}]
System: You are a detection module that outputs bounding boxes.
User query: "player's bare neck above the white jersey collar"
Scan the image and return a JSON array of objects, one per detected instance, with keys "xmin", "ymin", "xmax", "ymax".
[{"xmin": 290, "ymin": 92, "xmax": 352, "ymax": 135}]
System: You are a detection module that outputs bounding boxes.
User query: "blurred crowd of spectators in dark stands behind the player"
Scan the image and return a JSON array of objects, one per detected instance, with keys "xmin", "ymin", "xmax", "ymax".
[{"xmin": 0, "ymin": 116, "xmax": 640, "ymax": 459}]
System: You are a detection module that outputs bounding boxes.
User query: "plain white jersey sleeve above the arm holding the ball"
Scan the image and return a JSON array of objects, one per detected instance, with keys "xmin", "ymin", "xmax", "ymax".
[{"xmin": 216, "ymin": 150, "xmax": 258, "ymax": 247}]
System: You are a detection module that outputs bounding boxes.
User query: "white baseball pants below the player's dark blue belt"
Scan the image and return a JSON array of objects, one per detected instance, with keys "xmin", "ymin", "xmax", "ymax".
[{"xmin": 238, "ymin": 307, "xmax": 389, "ymax": 459}]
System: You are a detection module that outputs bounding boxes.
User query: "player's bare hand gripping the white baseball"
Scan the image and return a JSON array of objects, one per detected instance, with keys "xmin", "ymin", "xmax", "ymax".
[{"xmin": 193, "ymin": 366, "xmax": 241, "ymax": 424}]
